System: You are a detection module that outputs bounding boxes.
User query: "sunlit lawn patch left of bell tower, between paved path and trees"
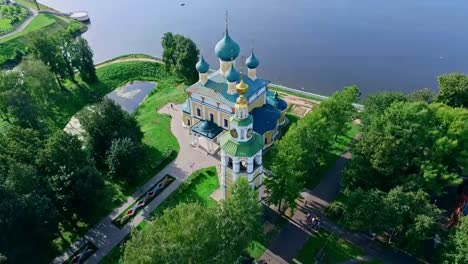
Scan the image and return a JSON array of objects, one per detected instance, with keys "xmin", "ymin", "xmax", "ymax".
[{"xmin": 151, "ymin": 167, "xmax": 219, "ymax": 217}]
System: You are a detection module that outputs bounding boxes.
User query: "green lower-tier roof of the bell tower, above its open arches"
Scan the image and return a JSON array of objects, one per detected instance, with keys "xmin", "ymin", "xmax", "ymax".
[{"xmin": 220, "ymin": 130, "xmax": 264, "ymax": 158}]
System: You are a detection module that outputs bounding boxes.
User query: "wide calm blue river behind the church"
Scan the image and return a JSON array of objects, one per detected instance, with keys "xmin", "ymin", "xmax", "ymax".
[{"xmin": 39, "ymin": 0, "xmax": 468, "ymax": 95}]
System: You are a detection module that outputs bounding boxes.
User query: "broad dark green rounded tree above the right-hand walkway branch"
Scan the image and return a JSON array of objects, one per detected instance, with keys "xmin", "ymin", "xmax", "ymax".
[{"xmin": 345, "ymin": 187, "xmax": 442, "ymax": 250}]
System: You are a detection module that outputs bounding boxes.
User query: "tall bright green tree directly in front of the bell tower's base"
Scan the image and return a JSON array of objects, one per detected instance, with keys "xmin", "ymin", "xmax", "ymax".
[{"xmin": 217, "ymin": 178, "xmax": 262, "ymax": 263}]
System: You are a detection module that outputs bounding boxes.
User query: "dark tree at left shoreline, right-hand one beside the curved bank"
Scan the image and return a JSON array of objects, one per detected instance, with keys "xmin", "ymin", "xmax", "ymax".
[{"xmin": 70, "ymin": 37, "xmax": 97, "ymax": 83}]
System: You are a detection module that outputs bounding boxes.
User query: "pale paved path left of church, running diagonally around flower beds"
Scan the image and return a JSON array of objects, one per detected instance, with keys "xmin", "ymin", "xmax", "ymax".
[{"xmin": 52, "ymin": 105, "xmax": 219, "ymax": 264}]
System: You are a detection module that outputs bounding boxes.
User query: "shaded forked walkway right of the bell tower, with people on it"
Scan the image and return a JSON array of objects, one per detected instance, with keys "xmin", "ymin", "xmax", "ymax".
[{"xmin": 260, "ymin": 138, "xmax": 415, "ymax": 264}]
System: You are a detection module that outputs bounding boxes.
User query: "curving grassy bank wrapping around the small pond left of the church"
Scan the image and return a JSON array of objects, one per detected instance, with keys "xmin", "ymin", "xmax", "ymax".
[{"xmin": 51, "ymin": 62, "xmax": 185, "ymax": 256}]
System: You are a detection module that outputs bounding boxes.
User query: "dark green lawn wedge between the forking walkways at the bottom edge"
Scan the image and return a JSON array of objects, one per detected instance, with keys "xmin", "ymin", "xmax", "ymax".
[{"xmin": 298, "ymin": 231, "xmax": 363, "ymax": 264}]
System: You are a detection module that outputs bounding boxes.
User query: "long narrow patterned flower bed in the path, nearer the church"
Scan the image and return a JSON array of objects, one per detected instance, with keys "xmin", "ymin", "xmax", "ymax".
[{"xmin": 112, "ymin": 175, "xmax": 175, "ymax": 228}]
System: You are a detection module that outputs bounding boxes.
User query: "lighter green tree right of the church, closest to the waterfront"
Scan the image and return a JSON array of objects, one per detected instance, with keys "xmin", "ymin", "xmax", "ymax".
[{"xmin": 319, "ymin": 86, "xmax": 360, "ymax": 141}]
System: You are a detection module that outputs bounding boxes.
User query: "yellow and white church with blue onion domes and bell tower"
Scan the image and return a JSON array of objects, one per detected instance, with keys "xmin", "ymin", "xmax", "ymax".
[{"xmin": 181, "ymin": 20, "xmax": 288, "ymax": 199}]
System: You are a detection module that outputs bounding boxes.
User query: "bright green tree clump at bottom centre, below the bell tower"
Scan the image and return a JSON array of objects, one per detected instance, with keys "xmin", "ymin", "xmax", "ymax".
[{"xmin": 122, "ymin": 179, "xmax": 261, "ymax": 264}]
